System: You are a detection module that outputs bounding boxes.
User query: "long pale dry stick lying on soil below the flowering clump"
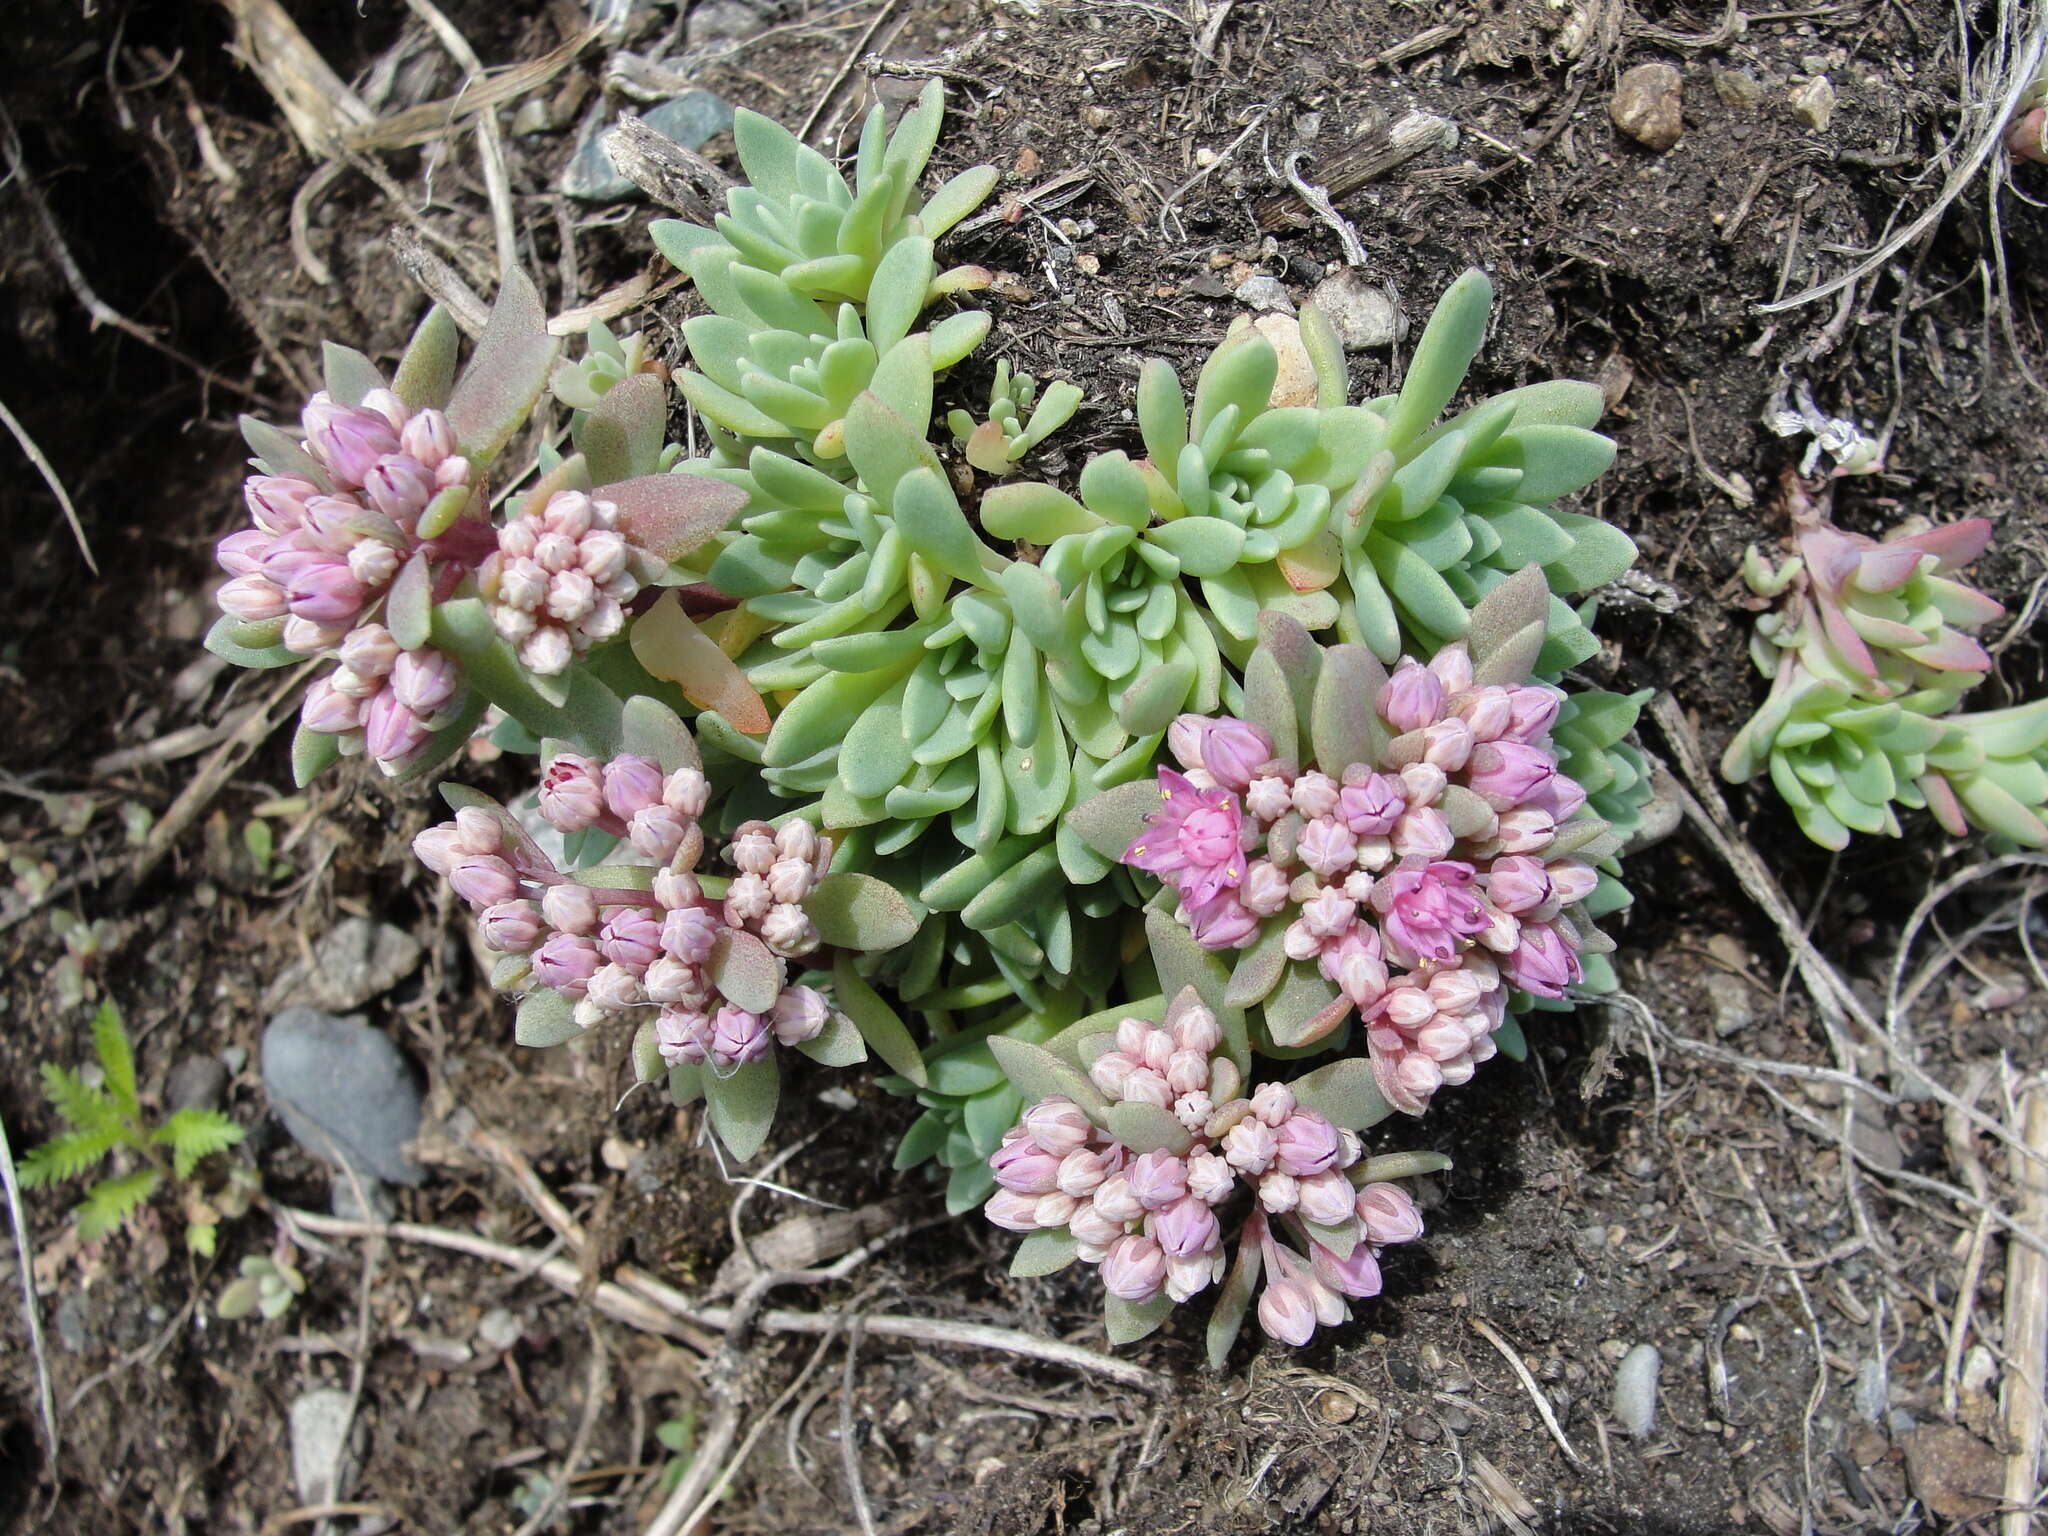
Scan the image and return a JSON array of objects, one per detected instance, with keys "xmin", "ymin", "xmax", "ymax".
[{"xmin": 276, "ymin": 1206, "xmax": 1167, "ymax": 1393}]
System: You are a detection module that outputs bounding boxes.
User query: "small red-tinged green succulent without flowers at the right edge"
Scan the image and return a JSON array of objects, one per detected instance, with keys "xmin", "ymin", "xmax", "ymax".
[{"xmin": 1722, "ymin": 485, "xmax": 2048, "ymax": 848}]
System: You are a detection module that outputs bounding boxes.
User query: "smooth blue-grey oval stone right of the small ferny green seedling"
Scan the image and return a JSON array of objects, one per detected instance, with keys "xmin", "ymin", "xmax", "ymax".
[{"xmin": 262, "ymin": 1008, "xmax": 426, "ymax": 1184}]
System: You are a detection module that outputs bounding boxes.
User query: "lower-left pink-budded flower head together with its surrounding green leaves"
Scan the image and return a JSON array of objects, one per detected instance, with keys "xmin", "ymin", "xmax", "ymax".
[{"xmin": 414, "ymin": 698, "xmax": 924, "ymax": 1157}]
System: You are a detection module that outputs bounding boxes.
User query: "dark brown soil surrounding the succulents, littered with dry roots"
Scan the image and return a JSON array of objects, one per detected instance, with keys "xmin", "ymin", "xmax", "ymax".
[{"xmin": 0, "ymin": 0, "xmax": 2048, "ymax": 1536}]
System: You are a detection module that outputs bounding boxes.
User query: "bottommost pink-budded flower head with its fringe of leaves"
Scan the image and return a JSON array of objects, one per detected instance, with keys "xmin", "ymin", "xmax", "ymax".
[{"xmin": 983, "ymin": 987, "xmax": 1446, "ymax": 1368}]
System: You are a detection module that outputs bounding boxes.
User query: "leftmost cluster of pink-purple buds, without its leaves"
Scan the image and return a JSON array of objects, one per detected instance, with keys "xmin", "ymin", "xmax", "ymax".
[{"xmin": 215, "ymin": 389, "xmax": 489, "ymax": 770}]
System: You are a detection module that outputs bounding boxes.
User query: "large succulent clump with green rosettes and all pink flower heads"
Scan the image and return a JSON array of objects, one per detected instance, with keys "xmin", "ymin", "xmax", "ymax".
[{"xmin": 192, "ymin": 82, "xmax": 1671, "ymax": 1364}]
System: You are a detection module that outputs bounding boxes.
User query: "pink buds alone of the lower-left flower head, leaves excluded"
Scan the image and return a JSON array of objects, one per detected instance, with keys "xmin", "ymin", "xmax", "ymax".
[{"xmin": 414, "ymin": 754, "xmax": 831, "ymax": 1067}]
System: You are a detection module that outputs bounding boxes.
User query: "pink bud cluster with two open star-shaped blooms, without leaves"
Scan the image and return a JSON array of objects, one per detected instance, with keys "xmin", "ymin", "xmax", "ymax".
[{"xmin": 1122, "ymin": 643, "xmax": 1599, "ymax": 1110}]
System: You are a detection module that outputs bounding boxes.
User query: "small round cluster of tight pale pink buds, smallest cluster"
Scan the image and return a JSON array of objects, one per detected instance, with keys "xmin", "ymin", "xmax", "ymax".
[{"xmin": 477, "ymin": 492, "xmax": 641, "ymax": 678}]
